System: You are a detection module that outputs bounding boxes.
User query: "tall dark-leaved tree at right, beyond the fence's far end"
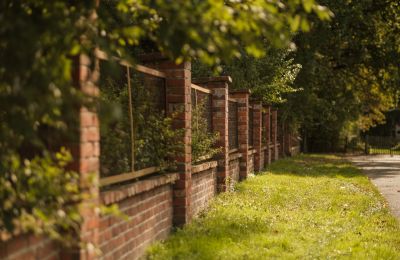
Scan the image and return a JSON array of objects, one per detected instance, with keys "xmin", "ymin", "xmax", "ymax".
[{"xmin": 282, "ymin": 0, "xmax": 400, "ymax": 151}]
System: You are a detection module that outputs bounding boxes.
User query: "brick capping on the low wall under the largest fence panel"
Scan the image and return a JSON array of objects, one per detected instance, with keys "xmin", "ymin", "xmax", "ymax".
[{"xmin": 100, "ymin": 173, "xmax": 179, "ymax": 205}]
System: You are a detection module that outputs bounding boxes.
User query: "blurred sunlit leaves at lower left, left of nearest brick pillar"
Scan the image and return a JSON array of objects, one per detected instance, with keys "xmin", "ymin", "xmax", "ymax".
[{"xmin": 0, "ymin": 148, "xmax": 82, "ymax": 244}]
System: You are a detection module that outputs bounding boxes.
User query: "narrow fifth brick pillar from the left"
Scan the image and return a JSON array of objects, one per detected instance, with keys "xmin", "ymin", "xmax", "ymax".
[{"xmin": 253, "ymin": 102, "xmax": 263, "ymax": 172}]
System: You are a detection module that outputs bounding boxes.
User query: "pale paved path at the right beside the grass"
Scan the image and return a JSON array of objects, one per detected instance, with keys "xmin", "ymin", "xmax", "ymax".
[{"xmin": 350, "ymin": 155, "xmax": 400, "ymax": 219}]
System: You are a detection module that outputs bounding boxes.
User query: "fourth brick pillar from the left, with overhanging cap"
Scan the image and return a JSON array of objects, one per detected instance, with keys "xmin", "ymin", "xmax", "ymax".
[{"xmin": 230, "ymin": 90, "xmax": 250, "ymax": 180}]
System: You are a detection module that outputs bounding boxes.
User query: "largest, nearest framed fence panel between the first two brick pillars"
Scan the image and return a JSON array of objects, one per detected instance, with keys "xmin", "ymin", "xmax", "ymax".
[{"xmin": 99, "ymin": 53, "xmax": 168, "ymax": 186}]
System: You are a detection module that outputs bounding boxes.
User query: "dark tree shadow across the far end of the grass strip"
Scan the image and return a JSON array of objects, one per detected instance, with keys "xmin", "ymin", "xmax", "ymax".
[{"xmin": 268, "ymin": 154, "xmax": 364, "ymax": 178}]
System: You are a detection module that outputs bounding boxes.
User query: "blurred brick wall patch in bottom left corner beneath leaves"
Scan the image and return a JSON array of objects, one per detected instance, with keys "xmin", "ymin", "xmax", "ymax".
[{"xmin": 0, "ymin": 235, "xmax": 60, "ymax": 260}]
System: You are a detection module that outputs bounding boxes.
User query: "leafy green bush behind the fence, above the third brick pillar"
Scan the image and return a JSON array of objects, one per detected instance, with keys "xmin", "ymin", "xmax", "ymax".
[{"xmin": 192, "ymin": 46, "xmax": 301, "ymax": 104}]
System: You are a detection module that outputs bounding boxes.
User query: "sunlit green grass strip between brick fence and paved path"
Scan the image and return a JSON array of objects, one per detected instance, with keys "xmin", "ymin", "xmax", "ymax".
[{"xmin": 146, "ymin": 155, "xmax": 400, "ymax": 259}]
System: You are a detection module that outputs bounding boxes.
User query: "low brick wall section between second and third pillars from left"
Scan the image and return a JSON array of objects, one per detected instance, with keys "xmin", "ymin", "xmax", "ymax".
[{"xmin": 190, "ymin": 161, "xmax": 217, "ymax": 216}]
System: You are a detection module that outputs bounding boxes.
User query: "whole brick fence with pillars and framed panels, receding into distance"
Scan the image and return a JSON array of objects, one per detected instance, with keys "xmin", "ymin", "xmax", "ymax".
[{"xmin": 0, "ymin": 52, "xmax": 300, "ymax": 259}]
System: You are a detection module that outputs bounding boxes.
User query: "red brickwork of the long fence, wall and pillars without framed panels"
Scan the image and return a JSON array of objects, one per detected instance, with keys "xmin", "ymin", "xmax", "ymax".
[{"xmin": 0, "ymin": 55, "xmax": 295, "ymax": 260}]
